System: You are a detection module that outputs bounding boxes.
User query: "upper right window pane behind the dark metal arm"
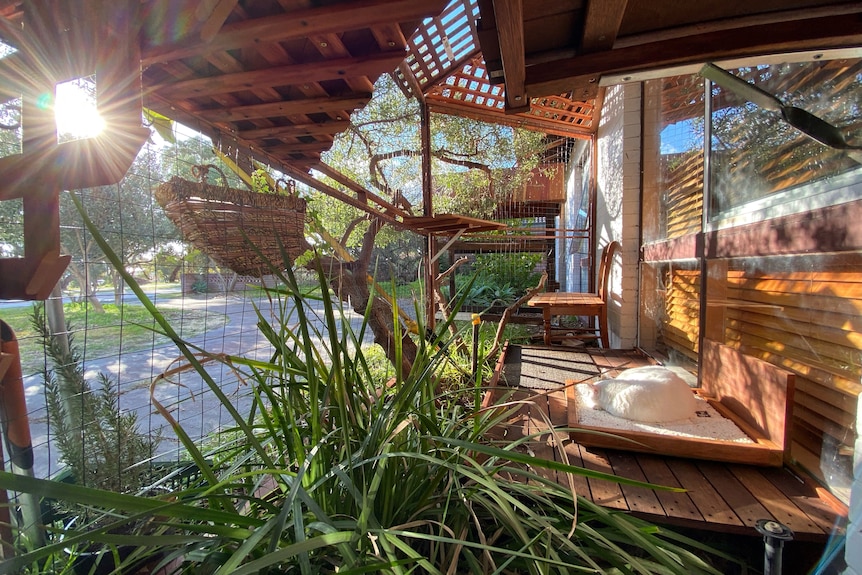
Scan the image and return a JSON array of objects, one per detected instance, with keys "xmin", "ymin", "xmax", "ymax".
[{"xmin": 710, "ymin": 60, "xmax": 862, "ymax": 220}]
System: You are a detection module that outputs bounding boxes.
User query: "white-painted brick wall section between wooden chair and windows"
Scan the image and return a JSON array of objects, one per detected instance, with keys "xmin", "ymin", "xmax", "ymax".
[{"xmin": 595, "ymin": 84, "xmax": 641, "ymax": 349}]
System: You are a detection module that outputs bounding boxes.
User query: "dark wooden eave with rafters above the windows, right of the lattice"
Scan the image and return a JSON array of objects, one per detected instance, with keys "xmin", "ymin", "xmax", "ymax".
[{"xmin": 477, "ymin": 0, "xmax": 862, "ymax": 107}]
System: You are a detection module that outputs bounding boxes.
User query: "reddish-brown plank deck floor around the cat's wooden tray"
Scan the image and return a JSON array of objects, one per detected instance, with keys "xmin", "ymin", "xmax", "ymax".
[{"xmin": 489, "ymin": 348, "xmax": 847, "ymax": 541}]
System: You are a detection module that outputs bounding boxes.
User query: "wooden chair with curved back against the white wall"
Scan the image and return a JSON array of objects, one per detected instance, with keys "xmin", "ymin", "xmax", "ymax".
[{"xmin": 527, "ymin": 241, "xmax": 620, "ymax": 349}]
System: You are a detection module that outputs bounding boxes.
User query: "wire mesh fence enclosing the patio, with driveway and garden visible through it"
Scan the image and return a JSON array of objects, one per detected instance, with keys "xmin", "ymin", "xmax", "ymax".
[{"xmin": 0, "ymin": 113, "xmax": 588, "ymax": 500}]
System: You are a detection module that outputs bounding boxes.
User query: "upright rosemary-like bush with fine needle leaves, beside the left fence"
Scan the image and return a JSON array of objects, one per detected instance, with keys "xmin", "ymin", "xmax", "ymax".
[{"xmin": 32, "ymin": 303, "xmax": 159, "ymax": 493}]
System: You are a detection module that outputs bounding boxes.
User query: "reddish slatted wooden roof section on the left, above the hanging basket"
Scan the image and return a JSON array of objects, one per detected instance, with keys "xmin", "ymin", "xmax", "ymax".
[{"xmin": 0, "ymin": 0, "xmax": 446, "ymax": 173}]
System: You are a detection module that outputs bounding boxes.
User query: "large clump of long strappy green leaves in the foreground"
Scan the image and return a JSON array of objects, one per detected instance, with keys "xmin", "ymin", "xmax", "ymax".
[{"xmin": 0, "ymin": 195, "xmax": 744, "ymax": 575}]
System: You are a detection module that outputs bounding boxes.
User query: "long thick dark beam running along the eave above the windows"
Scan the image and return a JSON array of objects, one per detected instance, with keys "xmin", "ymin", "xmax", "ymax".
[{"xmin": 525, "ymin": 14, "xmax": 862, "ymax": 100}]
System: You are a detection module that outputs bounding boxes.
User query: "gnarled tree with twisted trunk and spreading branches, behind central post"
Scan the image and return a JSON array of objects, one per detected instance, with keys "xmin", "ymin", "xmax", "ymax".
[{"xmin": 311, "ymin": 76, "xmax": 544, "ymax": 371}]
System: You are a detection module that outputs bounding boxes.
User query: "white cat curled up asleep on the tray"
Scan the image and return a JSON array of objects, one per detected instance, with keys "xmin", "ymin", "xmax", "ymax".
[{"xmin": 592, "ymin": 366, "xmax": 697, "ymax": 423}]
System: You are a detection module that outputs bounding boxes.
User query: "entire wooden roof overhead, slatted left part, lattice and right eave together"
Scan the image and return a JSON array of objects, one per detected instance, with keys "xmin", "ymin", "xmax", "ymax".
[{"xmin": 0, "ymin": 0, "xmax": 862, "ymax": 176}]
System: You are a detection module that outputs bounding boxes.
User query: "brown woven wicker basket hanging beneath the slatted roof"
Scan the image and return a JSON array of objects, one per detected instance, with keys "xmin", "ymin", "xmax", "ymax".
[{"xmin": 155, "ymin": 166, "xmax": 309, "ymax": 277}]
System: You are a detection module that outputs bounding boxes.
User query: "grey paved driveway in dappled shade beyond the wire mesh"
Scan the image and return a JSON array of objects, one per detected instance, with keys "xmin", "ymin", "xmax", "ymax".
[{"xmin": 19, "ymin": 292, "xmax": 372, "ymax": 477}]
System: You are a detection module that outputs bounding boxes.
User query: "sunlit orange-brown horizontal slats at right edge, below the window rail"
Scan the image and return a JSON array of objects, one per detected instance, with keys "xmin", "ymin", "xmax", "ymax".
[{"xmin": 725, "ymin": 254, "xmax": 862, "ymax": 484}]
